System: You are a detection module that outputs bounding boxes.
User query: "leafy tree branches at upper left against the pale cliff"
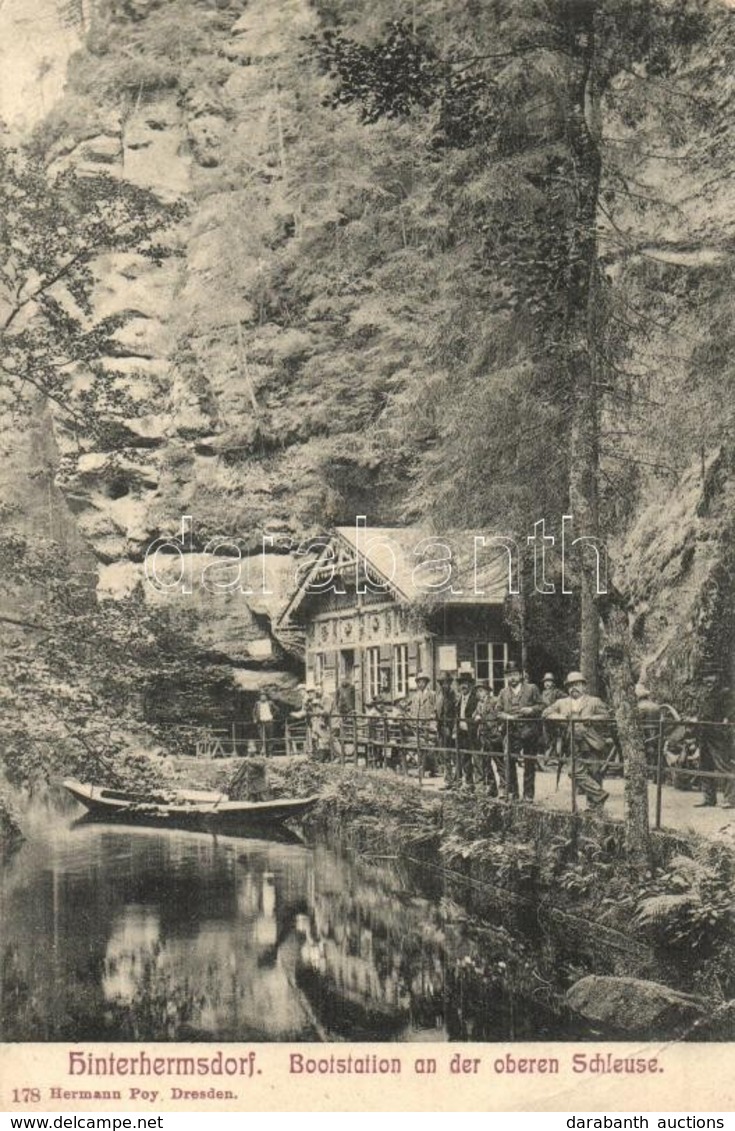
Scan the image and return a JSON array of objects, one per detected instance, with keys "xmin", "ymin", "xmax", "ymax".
[{"xmin": 0, "ymin": 140, "xmax": 182, "ymax": 436}]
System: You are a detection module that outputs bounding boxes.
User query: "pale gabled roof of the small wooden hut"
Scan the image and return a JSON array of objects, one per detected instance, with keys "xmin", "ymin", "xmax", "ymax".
[{"xmin": 274, "ymin": 526, "xmax": 509, "ymax": 625}]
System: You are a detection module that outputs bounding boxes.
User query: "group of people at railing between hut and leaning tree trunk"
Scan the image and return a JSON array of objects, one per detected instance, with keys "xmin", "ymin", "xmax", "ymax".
[{"xmin": 291, "ymin": 663, "xmax": 609, "ymax": 809}]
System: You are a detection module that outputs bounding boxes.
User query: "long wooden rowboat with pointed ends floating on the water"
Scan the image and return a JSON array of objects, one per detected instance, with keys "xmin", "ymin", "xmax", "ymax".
[{"xmin": 62, "ymin": 779, "xmax": 319, "ymax": 832}]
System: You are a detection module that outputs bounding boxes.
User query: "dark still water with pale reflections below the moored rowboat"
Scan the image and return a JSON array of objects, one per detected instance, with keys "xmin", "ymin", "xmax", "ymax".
[{"xmin": 0, "ymin": 817, "xmax": 586, "ymax": 1041}]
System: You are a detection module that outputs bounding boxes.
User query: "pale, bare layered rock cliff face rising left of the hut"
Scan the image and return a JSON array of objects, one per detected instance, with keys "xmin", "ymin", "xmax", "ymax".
[{"xmin": 23, "ymin": 0, "xmax": 330, "ymax": 666}]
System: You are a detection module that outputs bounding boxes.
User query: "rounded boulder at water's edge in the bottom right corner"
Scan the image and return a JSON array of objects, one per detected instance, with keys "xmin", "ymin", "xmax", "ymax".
[{"xmin": 567, "ymin": 974, "xmax": 707, "ymax": 1039}]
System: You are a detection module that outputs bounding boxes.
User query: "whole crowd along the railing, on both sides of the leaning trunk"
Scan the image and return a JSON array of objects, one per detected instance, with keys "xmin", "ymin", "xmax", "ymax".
[{"xmin": 279, "ymin": 662, "xmax": 735, "ymax": 811}]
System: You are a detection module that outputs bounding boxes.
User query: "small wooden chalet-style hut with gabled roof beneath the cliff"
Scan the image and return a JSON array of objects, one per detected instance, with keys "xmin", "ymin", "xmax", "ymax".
[{"xmin": 276, "ymin": 525, "xmax": 512, "ymax": 710}]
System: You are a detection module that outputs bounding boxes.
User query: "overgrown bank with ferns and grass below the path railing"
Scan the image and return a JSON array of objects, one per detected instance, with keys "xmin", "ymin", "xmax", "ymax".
[{"xmin": 167, "ymin": 759, "xmax": 735, "ymax": 1039}]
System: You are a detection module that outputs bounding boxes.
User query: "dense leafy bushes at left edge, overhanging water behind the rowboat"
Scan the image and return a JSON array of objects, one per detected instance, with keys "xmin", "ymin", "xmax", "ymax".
[{"xmin": 0, "ymin": 510, "xmax": 235, "ymax": 787}]
